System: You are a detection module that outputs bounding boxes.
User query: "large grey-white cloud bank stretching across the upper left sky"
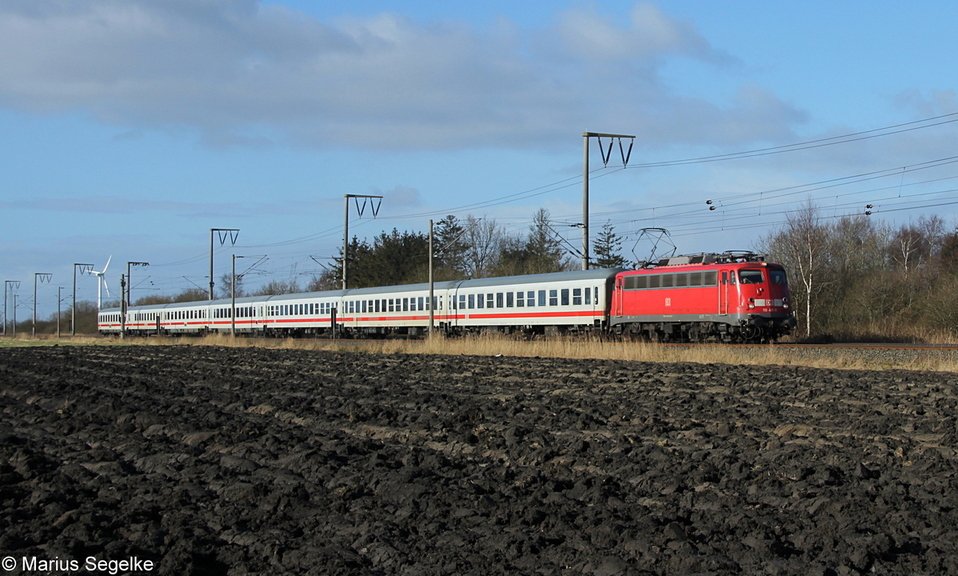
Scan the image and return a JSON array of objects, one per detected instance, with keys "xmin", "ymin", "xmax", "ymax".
[{"xmin": 0, "ymin": 0, "xmax": 801, "ymax": 149}]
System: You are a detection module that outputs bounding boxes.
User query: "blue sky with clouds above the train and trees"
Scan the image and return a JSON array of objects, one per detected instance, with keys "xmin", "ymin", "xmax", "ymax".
[{"xmin": 0, "ymin": 0, "xmax": 958, "ymax": 320}]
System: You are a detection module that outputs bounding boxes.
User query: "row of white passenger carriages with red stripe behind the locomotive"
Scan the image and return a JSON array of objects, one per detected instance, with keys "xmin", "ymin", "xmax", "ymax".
[{"xmin": 99, "ymin": 269, "xmax": 621, "ymax": 336}]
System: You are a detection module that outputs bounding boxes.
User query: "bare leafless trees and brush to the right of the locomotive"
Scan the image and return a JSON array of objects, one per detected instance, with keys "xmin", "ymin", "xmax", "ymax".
[{"xmin": 758, "ymin": 203, "xmax": 958, "ymax": 340}]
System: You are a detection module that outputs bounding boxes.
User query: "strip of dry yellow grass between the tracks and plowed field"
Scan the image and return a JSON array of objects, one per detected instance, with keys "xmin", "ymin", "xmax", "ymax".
[{"xmin": 0, "ymin": 335, "xmax": 958, "ymax": 372}]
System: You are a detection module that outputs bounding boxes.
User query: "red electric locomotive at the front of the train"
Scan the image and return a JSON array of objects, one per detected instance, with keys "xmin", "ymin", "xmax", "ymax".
[{"xmin": 609, "ymin": 252, "xmax": 796, "ymax": 342}]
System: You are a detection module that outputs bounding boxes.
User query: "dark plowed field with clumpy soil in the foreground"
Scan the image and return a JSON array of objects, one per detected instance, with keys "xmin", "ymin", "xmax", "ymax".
[{"xmin": 0, "ymin": 346, "xmax": 958, "ymax": 576}]
